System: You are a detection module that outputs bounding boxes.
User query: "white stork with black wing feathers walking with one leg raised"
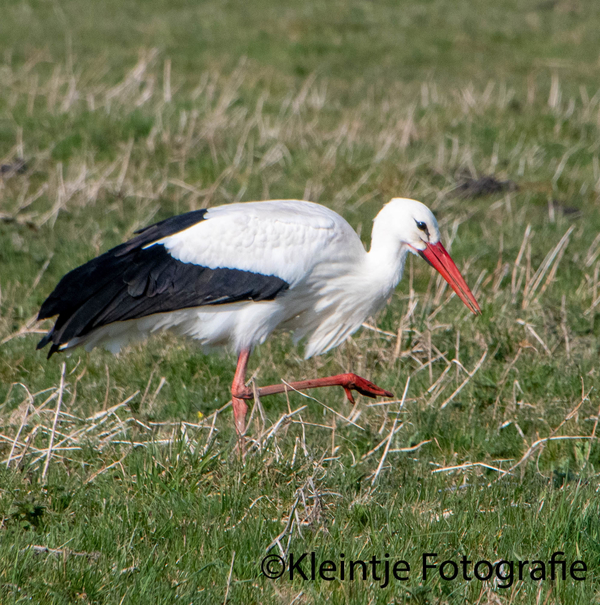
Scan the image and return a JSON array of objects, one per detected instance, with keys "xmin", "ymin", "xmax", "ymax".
[{"xmin": 38, "ymin": 198, "xmax": 481, "ymax": 437}]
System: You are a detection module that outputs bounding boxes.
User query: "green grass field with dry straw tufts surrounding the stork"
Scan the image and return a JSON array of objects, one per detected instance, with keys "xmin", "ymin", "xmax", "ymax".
[{"xmin": 0, "ymin": 0, "xmax": 600, "ymax": 605}]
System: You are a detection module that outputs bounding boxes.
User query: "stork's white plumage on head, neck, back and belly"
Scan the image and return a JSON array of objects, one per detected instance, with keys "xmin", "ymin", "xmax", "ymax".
[{"xmin": 60, "ymin": 199, "xmax": 439, "ymax": 358}]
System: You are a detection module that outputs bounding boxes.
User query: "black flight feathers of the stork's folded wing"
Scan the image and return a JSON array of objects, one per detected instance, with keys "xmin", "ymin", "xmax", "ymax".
[{"xmin": 37, "ymin": 210, "xmax": 289, "ymax": 357}]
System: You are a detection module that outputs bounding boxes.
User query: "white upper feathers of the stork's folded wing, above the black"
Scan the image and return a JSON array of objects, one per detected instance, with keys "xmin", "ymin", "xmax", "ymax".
[{"xmin": 156, "ymin": 200, "xmax": 364, "ymax": 286}]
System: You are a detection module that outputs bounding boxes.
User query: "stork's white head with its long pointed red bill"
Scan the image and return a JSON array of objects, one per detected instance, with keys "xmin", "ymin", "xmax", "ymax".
[{"xmin": 380, "ymin": 198, "xmax": 481, "ymax": 314}]
